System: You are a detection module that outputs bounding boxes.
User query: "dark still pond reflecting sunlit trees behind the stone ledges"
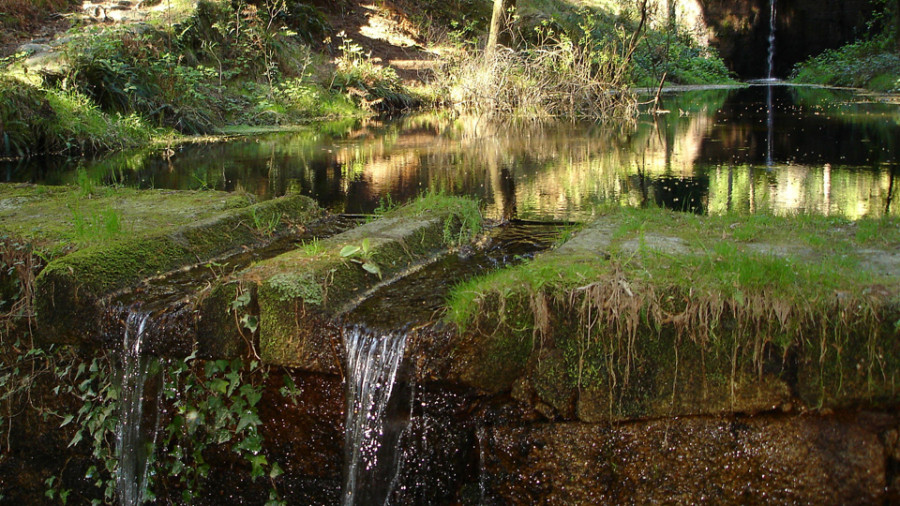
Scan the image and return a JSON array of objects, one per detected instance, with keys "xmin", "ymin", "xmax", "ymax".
[{"xmin": 0, "ymin": 85, "xmax": 900, "ymax": 220}]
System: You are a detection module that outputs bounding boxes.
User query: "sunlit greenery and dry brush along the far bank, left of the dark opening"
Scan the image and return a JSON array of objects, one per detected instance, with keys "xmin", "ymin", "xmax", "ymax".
[{"xmin": 0, "ymin": 0, "xmax": 740, "ymax": 156}]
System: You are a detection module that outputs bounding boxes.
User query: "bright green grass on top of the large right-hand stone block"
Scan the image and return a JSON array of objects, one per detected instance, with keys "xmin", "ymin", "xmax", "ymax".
[{"xmin": 448, "ymin": 208, "xmax": 900, "ymax": 328}]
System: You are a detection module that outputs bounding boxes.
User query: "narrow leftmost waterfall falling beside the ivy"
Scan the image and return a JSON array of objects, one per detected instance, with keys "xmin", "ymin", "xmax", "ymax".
[{"xmin": 116, "ymin": 311, "xmax": 159, "ymax": 506}]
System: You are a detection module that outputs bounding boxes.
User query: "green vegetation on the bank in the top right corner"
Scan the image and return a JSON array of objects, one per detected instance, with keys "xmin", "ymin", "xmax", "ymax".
[{"xmin": 790, "ymin": 0, "xmax": 900, "ymax": 93}]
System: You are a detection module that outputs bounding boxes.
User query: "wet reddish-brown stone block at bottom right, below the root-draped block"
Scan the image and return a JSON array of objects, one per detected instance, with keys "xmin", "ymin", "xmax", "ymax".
[{"xmin": 479, "ymin": 416, "xmax": 887, "ymax": 504}]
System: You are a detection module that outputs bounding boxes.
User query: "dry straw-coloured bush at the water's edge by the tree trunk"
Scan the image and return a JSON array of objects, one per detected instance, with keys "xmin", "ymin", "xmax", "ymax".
[{"xmin": 436, "ymin": 11, "xmax": 635, "ymax": 121}]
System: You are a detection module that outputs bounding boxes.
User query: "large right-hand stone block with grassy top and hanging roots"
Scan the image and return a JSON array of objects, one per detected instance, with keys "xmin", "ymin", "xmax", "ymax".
[{"xmin": 447, "ymin": 209, "xmax": 900, "ymax": 421}]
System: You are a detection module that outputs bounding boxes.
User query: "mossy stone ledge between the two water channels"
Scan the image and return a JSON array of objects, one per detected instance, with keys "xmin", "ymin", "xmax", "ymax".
[{"xmin": 199, "ymin": 197, "xmax": 480, "ymax": 368}]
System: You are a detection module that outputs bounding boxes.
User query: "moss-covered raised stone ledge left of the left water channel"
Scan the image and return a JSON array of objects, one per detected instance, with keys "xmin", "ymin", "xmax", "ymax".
[{"xmin": 35, "ymin": 195, "xmax": 322, "ymax": 344}]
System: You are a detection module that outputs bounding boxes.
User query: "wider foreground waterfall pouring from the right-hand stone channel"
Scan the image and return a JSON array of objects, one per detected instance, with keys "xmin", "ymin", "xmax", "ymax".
[{"xmin": 341, "ymin": 327, "xmax": 406, "ymax": 506}]
